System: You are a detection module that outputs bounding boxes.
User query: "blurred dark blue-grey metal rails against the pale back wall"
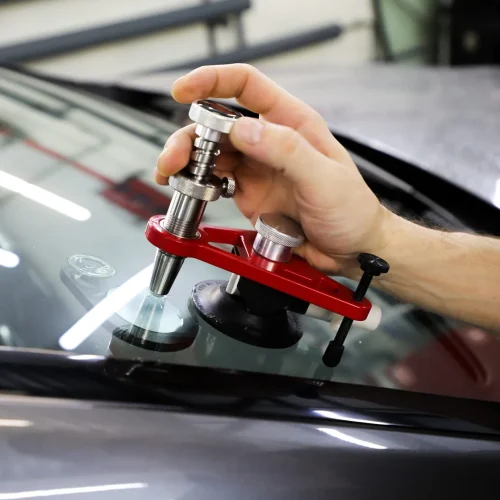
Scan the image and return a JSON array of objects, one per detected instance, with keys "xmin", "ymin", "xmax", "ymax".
[{"xmin": 0, "ymin": 0, "xmax": 343, "ymax": 77}]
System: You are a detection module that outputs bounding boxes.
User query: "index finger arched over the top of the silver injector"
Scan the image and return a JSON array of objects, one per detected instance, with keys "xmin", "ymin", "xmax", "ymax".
[{"xmin": 172, "ymin": 64, "xmax": 347, "ymax": 157}]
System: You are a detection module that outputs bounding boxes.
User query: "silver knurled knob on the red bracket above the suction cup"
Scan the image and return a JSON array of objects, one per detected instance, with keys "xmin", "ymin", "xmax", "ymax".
[{"xmin": 253, "ymin": 214, "xmax": 305, "ymax": 262}]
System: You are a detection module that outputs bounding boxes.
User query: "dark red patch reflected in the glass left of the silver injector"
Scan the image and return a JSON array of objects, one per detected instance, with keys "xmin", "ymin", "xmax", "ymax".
[{"xmin": 101, "ymin": 177, "xmax": 170, "ymax": 220}]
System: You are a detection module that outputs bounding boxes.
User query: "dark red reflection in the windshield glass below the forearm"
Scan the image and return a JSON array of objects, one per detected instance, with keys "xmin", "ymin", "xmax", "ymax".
[{"xmin": 387, "ymin": 326, "xmax": 500, "ymax": 401}]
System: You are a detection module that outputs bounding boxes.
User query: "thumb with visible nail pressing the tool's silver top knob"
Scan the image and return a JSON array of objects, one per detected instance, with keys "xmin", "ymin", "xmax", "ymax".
[{"xmin": 230, "ymin": 117, "xmax": 331, "ymax": 182}]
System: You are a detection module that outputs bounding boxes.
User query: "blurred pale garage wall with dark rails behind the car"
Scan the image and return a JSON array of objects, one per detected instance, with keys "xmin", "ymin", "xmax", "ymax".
[{"xmin": 0, "ymin": 0, "xmax": 500, "ymax": 79}]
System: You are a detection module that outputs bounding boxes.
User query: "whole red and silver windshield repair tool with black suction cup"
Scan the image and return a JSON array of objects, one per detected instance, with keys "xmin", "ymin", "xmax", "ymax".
[{"xmin": 146, "ymin": 100, "xmax": 389, "ymax": 367}]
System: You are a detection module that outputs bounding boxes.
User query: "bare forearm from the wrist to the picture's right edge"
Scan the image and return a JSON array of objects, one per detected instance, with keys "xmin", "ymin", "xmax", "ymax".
[{"xmin": 377, "ymin": 212, "xmax": 500, "ymax": 330}]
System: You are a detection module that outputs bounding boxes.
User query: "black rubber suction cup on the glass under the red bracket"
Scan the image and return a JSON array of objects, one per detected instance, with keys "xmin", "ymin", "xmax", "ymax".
[{"xmin": 191, "ymin": 280, "xmax": 302, "ymax": 349}]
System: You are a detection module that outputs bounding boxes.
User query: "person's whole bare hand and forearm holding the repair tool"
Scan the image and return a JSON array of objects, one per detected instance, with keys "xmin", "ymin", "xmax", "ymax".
[{"xmin": 155, "ymin": 64, "xmax": 500, "ymax": 329}]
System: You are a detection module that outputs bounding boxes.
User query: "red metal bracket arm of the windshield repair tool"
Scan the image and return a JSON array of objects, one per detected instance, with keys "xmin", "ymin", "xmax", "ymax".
[{"xmin": 146, "ymin": 215, "xmax": 371, "ymax": 321}]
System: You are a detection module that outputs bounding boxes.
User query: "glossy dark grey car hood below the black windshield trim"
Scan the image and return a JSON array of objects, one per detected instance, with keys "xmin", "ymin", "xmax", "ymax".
[{"xmin": 0, "ymin": 390, "xmax": 500, "ymax": 500}]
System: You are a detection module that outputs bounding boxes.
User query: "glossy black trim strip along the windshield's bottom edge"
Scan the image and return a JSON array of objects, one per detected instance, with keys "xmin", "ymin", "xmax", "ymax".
[{"xmin": 0, "ymin": 348, "xmax": 500, "ymax": 440}]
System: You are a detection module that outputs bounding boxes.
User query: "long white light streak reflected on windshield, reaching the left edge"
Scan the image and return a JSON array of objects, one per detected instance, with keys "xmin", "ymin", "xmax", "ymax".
[{"xmin": 0, "ymin": 170, "xmax": 91, "ymax": 221}]
